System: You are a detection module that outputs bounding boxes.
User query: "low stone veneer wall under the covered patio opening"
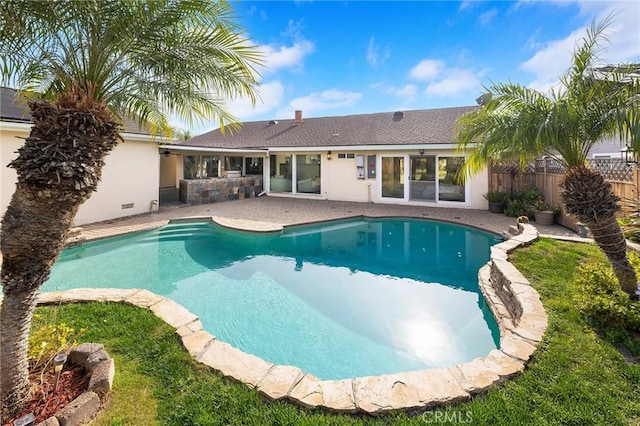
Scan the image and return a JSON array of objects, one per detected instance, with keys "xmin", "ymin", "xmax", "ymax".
[{"xmin": 180, "ymin": 176, "xmax": 263, "ymax": 204}]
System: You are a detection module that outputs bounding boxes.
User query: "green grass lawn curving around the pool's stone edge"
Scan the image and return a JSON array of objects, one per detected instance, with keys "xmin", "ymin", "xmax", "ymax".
[{"xmin": 32, "ymin": 239, "xmax": 640, "ymax": 426}]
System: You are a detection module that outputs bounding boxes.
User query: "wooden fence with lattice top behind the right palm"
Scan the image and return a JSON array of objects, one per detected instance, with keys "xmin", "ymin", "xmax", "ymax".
[{"xmin": 489, "ymin": 158, "xmax": 640, "ymax": 231}]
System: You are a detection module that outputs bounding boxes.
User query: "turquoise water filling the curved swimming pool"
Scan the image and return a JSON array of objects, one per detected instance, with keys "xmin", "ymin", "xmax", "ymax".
[{"xmin": 42, "ymin": 219, "xmax": 500, "ymax": 380}]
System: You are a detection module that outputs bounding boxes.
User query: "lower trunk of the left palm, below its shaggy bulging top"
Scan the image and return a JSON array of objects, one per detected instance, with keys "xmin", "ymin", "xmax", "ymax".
[{"xmin": 0, "ymin": 185, "xmax": 85, "ymax": 417}]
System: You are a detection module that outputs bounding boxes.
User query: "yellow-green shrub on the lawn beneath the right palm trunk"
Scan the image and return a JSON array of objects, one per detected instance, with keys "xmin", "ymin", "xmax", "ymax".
[{"xmin": 576, "ymin": 253, "xmax": 640, "ymax": 330}]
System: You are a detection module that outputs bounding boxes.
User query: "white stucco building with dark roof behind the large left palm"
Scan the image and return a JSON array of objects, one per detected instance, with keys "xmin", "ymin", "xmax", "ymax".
[{"xmin": 0, "ymin": 88, "xmax": 164, "ymax": 225}]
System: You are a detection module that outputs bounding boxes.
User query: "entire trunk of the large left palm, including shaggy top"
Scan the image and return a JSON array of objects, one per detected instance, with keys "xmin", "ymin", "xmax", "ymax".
[{"xmin": 0, "ymin": 91, "xmax": 121, "ymax": 418}]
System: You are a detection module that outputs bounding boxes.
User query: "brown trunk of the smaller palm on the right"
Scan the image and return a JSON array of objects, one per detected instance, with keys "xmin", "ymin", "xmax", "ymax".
[{"xmin": 560, "ymin": 166, "xmax": 638, "ymax": 299}]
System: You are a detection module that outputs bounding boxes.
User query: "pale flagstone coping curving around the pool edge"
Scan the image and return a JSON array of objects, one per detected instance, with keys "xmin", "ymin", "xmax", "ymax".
[{"xmin": 27, "ymin": 217, "xmax": 547, "ymax": 415}]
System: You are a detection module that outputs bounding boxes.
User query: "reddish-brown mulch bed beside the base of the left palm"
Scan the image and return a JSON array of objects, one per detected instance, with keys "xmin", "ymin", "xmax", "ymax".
[{"xmin": 4, "ymin": 365, "xmax": 89, "ymax": 426}]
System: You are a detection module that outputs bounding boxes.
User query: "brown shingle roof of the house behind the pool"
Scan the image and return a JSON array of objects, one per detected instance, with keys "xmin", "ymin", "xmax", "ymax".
[{"xmin": 179, "ymin": 106, "xmax": 478, "ymax": 149}]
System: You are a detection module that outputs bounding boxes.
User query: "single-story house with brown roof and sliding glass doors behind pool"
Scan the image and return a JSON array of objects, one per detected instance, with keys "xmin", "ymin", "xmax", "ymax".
[{"xmin": 160, "ymin": 106, "xmax": 488, "ymax": 209}]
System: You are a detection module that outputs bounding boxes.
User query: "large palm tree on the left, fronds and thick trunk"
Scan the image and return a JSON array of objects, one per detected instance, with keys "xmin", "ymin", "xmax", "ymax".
[{"xmin": 0, "ymin": 0, "xmax": 261, "ymax": 418}]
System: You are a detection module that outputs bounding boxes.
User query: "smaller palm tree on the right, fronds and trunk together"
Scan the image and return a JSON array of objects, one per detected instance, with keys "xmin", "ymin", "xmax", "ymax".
[{"xmin": 456, "ymin": 17, "xmax": 640, "ymax": 298}]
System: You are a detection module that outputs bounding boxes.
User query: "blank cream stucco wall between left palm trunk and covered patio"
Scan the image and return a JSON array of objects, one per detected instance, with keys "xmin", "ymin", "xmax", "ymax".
[{"xmin": 75, "ymin": 137, "xmax": 160, "ymax": 225}]
